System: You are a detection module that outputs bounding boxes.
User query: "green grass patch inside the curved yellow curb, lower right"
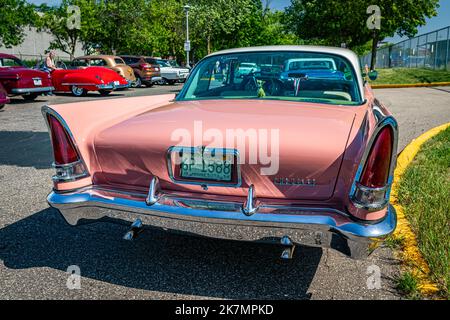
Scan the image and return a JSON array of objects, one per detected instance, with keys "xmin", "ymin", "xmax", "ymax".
[{"xmin": 398, "ymin": 128, "xmax": 450, "ymax": 298}]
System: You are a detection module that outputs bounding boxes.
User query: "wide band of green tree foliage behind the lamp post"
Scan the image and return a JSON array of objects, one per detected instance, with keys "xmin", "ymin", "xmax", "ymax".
[{"xmin": 31, "ymin": 0, "xmax": 299, "ymax": 60}]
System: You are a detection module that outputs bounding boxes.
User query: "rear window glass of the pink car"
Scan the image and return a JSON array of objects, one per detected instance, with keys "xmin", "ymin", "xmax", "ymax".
[{"xmin": 177, "ymin": 51, "xmax": 362, "ymax": 105}]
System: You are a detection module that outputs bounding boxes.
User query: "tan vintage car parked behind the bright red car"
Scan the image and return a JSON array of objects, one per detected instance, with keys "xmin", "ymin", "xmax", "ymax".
[{"xmin": 71, "ymin": 55, "xmax": 136, "ymax": 86}]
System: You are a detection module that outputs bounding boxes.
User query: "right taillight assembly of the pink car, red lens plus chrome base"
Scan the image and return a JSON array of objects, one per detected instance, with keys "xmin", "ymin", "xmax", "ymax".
[{"xmin": 353, "ymin": 126, "xmax": 394, "ymax": 211}]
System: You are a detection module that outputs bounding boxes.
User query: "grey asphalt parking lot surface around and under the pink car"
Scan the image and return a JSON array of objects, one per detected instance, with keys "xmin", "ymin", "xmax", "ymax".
[{"xmin": 0, "ymin": 85, "xmax": 450, "ymax": 299}]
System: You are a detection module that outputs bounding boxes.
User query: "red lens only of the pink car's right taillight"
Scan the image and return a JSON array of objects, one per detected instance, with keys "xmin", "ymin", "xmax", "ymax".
[{"xmin": 359, "ymin": 126, "xmax": 392, "ymax": 188}]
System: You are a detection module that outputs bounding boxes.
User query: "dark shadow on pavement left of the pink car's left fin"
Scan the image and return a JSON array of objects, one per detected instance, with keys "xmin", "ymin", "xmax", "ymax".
[{"xmin": 0, "ymin": 131, "xmax": 53, "ymax": 169}]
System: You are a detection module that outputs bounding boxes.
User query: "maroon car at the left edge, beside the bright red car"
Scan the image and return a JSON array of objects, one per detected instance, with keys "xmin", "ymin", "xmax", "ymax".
[{"xmin": 0, "ymin": 53, "xmax": 54, "ymax": 100}]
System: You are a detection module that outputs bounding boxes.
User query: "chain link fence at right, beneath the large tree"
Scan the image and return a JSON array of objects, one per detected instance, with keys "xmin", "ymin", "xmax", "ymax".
[{"xmin": 361, "ymin": 26, "xmax": 450, "ymax": 70}]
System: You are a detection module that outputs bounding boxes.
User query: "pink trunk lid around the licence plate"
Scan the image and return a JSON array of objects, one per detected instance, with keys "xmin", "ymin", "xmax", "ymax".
[{"xmin": 94, "ymin": 100, "xmax": 355, "ymax": 200}]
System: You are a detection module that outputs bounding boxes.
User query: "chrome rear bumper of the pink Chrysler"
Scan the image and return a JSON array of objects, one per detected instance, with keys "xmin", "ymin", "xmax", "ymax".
[{"xmin": 47, "ymin": 187, "xmax": 397, "ymax": 259}]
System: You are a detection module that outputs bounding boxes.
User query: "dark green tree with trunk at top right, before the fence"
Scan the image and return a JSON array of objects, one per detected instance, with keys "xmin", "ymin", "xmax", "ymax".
[{"xmin": 286, "ymin": 0, "xmax": 439, "ymax": 69}]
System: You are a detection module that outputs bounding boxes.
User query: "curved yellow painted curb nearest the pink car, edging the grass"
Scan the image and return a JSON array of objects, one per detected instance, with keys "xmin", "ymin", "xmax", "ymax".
[{"xmin": 391, "ymin": 123, "xmax": 450, "ymax": 296}]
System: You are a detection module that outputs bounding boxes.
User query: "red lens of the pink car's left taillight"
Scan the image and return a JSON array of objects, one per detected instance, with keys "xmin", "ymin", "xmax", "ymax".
[{"xmin": 47, "ymin": 115, "xmax": 80, "ymax": 165}]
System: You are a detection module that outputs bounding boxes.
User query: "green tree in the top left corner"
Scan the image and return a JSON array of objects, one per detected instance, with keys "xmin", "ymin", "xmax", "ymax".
[{"xmin": 0, "ymin": 0, "xmax": 36, "ymax": 48}]
